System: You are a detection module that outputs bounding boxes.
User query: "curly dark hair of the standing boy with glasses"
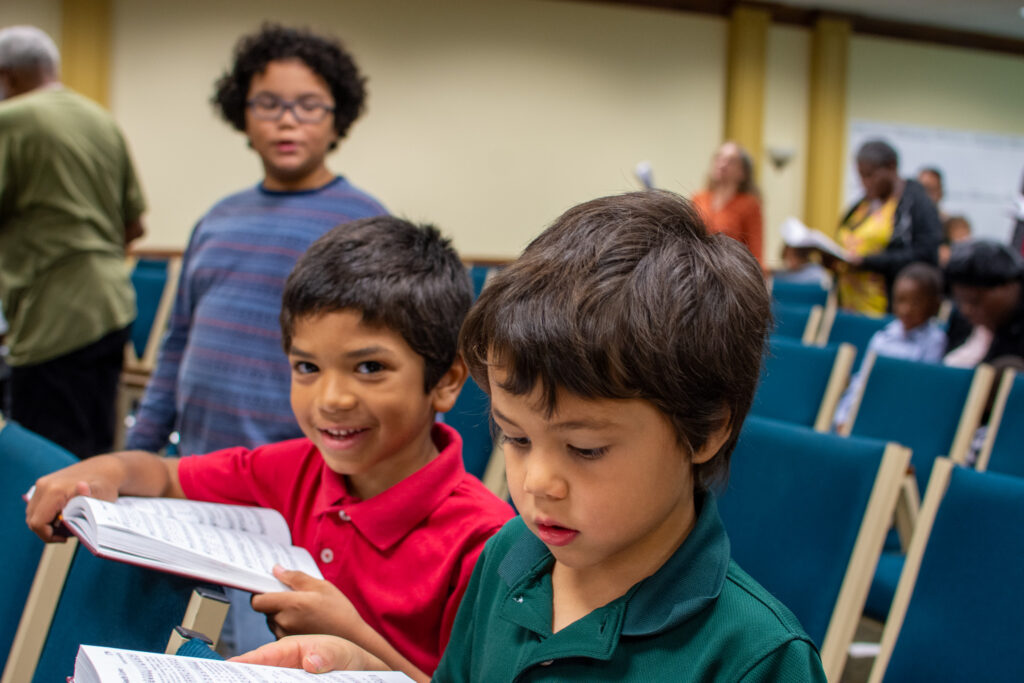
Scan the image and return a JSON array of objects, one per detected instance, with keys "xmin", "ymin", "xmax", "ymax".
[{"xmin": 211, "ymin": 24, "xmax": 367, "ymax": 150}]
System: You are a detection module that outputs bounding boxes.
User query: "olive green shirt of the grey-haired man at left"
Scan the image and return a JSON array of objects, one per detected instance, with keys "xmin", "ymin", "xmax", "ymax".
[{"xmin": 0, "ymin": 88, "xmax": 144, "ymax": 366}]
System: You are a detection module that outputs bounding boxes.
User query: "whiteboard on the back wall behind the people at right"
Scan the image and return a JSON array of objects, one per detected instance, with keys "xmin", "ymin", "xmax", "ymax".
[{"xmin": 844, "ymin": 119, "xmax": 1024, "ymax": 243}]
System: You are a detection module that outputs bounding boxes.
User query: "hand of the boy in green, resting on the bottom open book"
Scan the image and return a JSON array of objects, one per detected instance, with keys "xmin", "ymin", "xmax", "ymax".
[{"xmin": 229, "ymin": 634, "xmax": 390, "ymax": 674}]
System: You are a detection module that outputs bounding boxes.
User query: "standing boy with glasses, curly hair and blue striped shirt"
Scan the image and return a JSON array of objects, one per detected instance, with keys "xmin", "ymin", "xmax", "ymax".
[{"xmin": 126, "ymin": 25, "xmax": 387, "ymax": 649}]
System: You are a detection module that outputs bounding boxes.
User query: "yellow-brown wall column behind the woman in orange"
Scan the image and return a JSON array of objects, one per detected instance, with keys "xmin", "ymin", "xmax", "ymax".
[{"xmin": 725, "ymin": 6, "xmax": 771, "ymax": 175}]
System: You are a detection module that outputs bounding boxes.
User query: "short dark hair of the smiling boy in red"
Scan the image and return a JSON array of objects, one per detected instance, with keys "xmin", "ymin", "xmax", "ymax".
[{"xmin": 281, "ymin": 216, "xmax": 472, "ymax": 391}]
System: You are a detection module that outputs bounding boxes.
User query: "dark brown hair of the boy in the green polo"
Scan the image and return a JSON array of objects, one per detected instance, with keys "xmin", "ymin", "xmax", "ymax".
[{"xmin": 459, "ymin": 191, "xmax": 771, "ymax": 490}]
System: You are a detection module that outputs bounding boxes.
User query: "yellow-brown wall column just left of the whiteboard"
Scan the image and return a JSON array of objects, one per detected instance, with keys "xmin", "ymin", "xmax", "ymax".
[{"xmin": 804, "ymin": 18, "xmax": 850, "ymax": 233}]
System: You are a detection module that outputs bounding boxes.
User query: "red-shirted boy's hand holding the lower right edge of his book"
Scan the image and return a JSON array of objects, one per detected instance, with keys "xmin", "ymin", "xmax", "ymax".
[{"xmin": 252, "ymin": 566, "xmax": 370, "ymax": 641}]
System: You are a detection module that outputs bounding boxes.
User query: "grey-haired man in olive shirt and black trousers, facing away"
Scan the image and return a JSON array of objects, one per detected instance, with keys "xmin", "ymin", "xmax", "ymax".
[{"xmin": 0, "ymin": 27, "xmax": 144, "ymax": 458}]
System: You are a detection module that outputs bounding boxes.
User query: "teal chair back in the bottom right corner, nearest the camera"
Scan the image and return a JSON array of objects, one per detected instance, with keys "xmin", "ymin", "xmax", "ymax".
[{"xmin": 885, "ymin": 467, "xmax": 1024, "ymax": 683}]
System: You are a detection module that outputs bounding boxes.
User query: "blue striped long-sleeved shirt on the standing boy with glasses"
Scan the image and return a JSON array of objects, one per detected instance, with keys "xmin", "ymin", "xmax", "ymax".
[{"xmin": 126, "ymin": 177, "xmax": 387, "ymax": 455}]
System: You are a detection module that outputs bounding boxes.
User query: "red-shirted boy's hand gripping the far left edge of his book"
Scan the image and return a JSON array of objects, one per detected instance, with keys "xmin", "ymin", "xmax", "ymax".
[{"xmin": 25, "ymin": 456, "xmax": 124, "ymax": 543}]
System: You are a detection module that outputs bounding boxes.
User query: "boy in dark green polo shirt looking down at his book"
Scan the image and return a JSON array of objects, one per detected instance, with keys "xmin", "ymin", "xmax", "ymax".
[{"xmin": 235, "ymin": 191, "xmax": 824, "ymax": 682}]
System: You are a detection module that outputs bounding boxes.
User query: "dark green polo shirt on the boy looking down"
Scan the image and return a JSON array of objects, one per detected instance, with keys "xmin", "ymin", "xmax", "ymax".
[{"xmin": 434, "ymin": 494, "xmax": 825, "ymax": 683}]
